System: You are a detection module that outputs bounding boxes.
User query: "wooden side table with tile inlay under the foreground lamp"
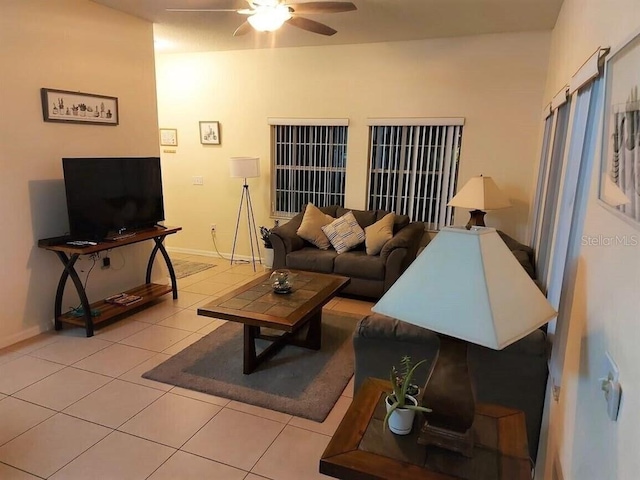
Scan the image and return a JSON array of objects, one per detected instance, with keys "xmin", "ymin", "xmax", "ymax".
[{"xmin": 320, "ymin": 378, "xmax": 531, "ymax": 480}]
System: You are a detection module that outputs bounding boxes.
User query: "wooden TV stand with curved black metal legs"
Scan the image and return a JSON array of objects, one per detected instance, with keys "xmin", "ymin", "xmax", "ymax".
[{"xmin": 38, "ymin": 227, "xmax": 182, "ymax": 337}]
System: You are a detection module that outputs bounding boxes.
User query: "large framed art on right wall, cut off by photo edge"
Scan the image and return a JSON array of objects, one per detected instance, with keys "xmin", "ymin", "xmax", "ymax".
[{"xmin": 599, "ymin": 33, "xmax": 640, "ymax": 228}]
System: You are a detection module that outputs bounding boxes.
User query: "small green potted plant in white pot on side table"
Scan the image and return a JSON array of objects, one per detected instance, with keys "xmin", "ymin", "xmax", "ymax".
[{"xmin": 384, "ymin": 355, "xmax": 431, "ymax": 435}]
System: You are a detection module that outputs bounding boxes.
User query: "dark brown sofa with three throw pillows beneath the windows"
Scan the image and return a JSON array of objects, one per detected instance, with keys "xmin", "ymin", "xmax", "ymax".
[{"xmin": 269, "ymin": 205, "xmax": 424, "ymax": 299}]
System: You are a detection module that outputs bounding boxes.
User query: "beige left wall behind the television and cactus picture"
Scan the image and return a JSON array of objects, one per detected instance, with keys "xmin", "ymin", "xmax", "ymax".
[{"xmin": 0, "ymin": 0, "xmax": 159, "ymax": 347}]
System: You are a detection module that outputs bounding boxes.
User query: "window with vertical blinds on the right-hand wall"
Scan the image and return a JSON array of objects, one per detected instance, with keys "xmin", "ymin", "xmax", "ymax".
[{"xmin": 532, "ymin": 49, "xmax": 609, "ymax": 400}]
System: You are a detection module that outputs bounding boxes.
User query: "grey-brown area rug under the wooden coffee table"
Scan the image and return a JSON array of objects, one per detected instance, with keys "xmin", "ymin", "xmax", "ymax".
[{"xmin": 142, "ymin": 311, "xmax": 362, "ymax": 422}]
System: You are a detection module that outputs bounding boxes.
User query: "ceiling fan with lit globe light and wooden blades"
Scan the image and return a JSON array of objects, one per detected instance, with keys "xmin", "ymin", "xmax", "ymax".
[{"xmin": 167, "ymin": 0, "xmax": 357, "ymax": 37}]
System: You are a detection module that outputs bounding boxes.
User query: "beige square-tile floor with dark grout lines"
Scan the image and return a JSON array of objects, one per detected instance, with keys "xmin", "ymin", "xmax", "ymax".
[{"xmin": 0, "ymin": 254, "xmax": 372, "ymax": 480}]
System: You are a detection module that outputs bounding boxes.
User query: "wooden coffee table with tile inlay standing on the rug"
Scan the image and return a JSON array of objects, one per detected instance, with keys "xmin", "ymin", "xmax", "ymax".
[{"xmin": 198, "ymin": 271, "xmax": 351, "ymax": 374}]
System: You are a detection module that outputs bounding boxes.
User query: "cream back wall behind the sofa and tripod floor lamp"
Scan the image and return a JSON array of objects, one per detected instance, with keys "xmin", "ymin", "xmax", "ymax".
[{"xmin": 156, "ymin": 33, "xmax": 549, "ymax": 254}]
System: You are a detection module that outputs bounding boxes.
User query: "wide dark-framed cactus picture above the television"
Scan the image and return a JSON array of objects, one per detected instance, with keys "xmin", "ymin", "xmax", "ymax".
[{"xmin": 40, "ymin": 88, "xmax": 119, "ymax": 126}]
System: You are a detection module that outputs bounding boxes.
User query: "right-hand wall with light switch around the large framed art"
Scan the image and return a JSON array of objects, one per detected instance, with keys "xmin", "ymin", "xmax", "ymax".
[{"xmin": 540, "ymin": 0, "xmax": 640, "ymax": 480}]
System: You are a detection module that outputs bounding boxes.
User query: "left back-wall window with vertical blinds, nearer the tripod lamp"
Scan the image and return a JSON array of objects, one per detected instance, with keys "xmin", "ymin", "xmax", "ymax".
[{"xmin": 269, "ymin": 118, "xmax": 348, "ymax": 216}]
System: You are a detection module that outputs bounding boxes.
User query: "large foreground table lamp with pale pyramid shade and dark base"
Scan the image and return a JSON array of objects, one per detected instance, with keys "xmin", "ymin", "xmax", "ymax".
[{"xmin": 372, "ymin": 227, "xmax": 556, "ymax": 456}]
